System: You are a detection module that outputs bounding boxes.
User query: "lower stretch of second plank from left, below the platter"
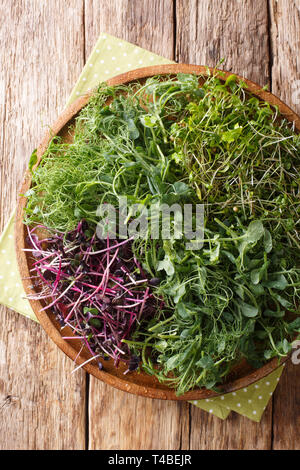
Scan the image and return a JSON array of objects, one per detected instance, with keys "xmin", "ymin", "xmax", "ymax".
[{"xmin": 89, "ymin": 377, "xmax": 189, "ymax": 450}]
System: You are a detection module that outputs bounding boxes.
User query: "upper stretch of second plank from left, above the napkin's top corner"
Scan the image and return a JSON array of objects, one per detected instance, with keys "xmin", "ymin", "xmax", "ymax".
[{"xmin": 85, "ymin": 0, "xmax": 174, "ymax": 59}]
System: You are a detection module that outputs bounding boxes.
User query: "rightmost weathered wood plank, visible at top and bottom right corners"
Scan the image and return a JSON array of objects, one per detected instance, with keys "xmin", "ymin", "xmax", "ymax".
[{"xmin": 270, "ymin": 0, "xmax": 300, "ymax": 450}]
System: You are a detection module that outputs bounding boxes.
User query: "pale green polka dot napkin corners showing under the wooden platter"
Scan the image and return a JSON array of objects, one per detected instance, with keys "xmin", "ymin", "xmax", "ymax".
[{"xmin": 0, "ymin": 34, "xmax": 283, "ymax": 422}]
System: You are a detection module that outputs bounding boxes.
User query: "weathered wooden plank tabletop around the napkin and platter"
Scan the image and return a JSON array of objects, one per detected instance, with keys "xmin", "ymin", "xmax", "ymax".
[{"xmin": 0, "ymin": 0, "xmax": 300, "ymax": 450}]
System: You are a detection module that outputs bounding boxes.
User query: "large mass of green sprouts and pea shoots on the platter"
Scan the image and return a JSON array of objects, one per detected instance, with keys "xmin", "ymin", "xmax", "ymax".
[{"xmin": 26, "ymin": 74, "xmax": 300, "ymax": 394}]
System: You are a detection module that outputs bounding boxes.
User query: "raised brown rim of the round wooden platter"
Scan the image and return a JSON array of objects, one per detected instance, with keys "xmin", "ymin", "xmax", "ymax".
[{"xmin": 15, "ymin": 64, "xmax": 300, "ymax": 401}]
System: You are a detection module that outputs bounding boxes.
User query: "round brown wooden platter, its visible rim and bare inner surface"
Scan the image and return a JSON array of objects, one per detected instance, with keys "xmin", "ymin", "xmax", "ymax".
[{"xmin": 15, "ymin": 64, "xmax": 300, "ymax": 400}]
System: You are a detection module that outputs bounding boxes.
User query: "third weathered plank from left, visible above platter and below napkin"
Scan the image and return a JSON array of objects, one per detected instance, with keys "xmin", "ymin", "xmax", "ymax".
[{"xmin": 176, "ymin": 0, "xmax": 272, "ymax": 449}]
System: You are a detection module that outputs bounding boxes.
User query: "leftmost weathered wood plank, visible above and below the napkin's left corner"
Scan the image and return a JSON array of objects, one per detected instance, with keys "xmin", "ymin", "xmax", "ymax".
[{"xmin": 0, "ymin": 0, "xmax": 86, "ymax": 450}]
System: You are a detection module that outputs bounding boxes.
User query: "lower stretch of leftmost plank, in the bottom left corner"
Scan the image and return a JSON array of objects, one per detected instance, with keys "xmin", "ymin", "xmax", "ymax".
[{"xmin": 0, "ymin": 308, "xmax": 86, "ymax": 450}]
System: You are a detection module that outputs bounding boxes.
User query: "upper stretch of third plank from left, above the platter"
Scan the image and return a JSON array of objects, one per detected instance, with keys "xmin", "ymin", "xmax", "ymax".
[{"xmin": 176, "ymin": 0, "xmax": 269, "ymax": 85}]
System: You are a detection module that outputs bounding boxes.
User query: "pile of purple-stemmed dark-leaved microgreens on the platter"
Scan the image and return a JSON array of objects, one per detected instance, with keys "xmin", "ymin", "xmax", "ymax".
[{"xmin": 27, "ymin": 222, "xmax": 161, "ymax": 370}]
